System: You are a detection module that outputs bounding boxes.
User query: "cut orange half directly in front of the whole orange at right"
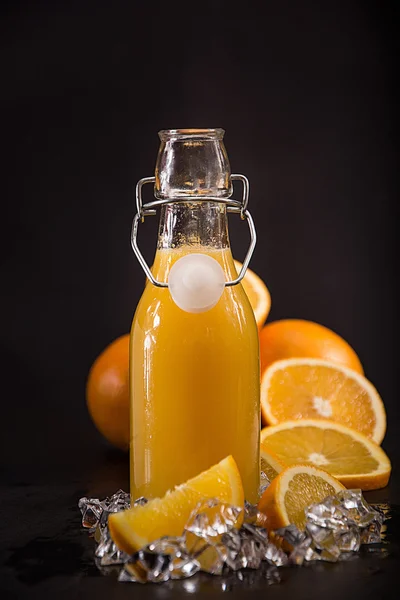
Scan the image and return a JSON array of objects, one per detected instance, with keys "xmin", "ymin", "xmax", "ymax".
[{"xmin": 261, "ymin": 358, "xmax": 386, "ymax": 444}]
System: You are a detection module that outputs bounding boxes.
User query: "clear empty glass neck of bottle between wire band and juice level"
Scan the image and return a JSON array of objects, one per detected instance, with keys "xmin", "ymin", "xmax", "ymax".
[{"xmin": 157, "ymin": 200, "xmax": 230, "ymax": 249}]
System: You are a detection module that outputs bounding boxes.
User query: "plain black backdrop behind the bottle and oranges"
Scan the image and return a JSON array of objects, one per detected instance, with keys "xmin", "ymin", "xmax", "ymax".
[{"xmin": 0, "ymin": 0, "xmax": 400, "ymax": 597}]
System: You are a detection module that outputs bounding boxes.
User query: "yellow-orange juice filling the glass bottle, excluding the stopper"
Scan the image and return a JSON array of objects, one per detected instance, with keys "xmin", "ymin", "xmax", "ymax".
[{"xmin": 130, "ymin": 245, "xmax": 260, "ymax": 502}]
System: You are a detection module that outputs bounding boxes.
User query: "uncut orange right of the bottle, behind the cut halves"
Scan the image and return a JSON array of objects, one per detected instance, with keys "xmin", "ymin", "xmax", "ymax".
[{"xmin": 260, "ymin": 319, "xmax": 363, "ymax": 373}]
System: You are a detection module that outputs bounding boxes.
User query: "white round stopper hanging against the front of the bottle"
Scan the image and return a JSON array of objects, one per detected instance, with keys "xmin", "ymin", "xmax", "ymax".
[{"xmin": 168, "ymin": 254, "xmax": 225, "ymax": 313}]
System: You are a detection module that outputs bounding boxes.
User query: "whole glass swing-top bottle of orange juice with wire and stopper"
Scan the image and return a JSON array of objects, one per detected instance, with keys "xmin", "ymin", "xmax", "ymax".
[{"xmin": 130, "ymin": 129, "xmax": 260, "ymax": 502}]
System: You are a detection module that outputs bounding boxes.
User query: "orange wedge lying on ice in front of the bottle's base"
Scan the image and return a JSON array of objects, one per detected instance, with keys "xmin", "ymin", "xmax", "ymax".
[{"xmin": 108, "ymin": 456, "xmax": 244, "ymax": 554}]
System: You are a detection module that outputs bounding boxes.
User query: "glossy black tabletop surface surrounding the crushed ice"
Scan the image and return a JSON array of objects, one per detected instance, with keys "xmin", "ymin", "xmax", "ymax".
[{"xmin": 0, "ymin": 448, "xmax": 400, "ymax": 600}]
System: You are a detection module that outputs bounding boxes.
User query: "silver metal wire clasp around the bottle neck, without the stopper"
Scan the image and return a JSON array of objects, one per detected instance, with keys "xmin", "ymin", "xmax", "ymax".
[{"xmin": 131, "ymin": 174, "xmax": 257, "ymax": 288}]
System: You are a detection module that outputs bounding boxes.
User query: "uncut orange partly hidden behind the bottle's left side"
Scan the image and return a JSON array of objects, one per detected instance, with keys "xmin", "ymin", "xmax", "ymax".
[{"xmin": 86, "ymin": 335, "xmax": 129, "ymax": 450}]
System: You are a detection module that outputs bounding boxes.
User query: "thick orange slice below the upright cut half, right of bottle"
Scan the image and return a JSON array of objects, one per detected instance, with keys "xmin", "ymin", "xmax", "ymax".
[{"xmin": 261, "ymin": 419, "xmax": 391, "ymax": 490}]
